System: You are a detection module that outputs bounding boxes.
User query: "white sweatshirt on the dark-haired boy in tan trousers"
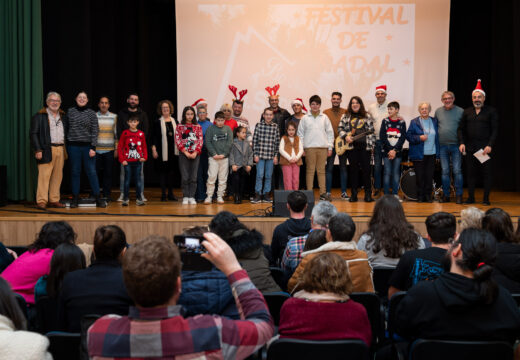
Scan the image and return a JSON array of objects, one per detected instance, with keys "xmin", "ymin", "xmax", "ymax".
[{"xmin": 297, "ymin": 112, "xmax": 334, "ymax": 150}]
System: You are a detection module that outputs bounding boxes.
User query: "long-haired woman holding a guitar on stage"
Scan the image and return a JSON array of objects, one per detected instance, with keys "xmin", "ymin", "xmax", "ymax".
[{"xmin": 338, "ymin": 96, "xmax": 376, "ymax": 202}]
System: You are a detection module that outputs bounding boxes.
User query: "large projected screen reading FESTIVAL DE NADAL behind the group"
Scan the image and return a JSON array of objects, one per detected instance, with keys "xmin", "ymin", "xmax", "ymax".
[{"xmin": 176, "ymin": 0, "xmax": 449, "ymax": 127}]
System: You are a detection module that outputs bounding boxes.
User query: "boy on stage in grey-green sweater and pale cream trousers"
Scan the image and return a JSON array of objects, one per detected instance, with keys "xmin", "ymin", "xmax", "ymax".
[{"xmin": 204, "ymin": 111, "xmax": 233, "ymax": 205}]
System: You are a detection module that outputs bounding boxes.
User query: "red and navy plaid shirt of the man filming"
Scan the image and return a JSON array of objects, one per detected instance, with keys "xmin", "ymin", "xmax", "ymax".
[{"xmin": 88, "ymin": 270, "xmax": 274, "ymax": 360}]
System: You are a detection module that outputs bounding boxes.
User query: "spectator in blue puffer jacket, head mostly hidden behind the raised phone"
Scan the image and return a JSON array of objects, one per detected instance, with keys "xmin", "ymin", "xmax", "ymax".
[{"xmin": 177, "ymin": 226, "xmax": 238, "ymax": 319}]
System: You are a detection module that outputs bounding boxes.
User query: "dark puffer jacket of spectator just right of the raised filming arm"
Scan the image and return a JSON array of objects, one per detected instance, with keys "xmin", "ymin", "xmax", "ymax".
[{"xmin": 227, "ymin": 229, "xmax": 281, "ymax": 293}]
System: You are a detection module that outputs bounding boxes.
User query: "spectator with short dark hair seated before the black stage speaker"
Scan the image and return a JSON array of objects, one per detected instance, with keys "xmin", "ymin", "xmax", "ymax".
[{"xmin": 271, "ymin": 191, "xmax": 311, "ymax": 266}]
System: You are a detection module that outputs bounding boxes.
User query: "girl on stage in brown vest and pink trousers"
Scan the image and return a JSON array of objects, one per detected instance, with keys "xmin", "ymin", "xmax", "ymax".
[{"xmin": 279, "ymin": 121, "xmax": 303, "ymax": 190}]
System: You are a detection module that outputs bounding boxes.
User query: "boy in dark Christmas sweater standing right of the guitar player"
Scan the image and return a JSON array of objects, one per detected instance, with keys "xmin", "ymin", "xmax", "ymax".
[{"xmin": 379, "ymin": 101, "xmax": 406, "ymax": 198}]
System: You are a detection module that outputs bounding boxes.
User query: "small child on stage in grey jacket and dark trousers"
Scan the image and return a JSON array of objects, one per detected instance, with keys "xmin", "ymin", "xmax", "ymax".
[{"xmin": 229, "ymin": 126, "xmax": 253, "ymax": 204}]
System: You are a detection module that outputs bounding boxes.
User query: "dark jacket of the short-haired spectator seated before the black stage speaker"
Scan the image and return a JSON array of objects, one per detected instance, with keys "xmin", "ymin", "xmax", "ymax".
[{"xmin": 271, "ymin": 218, "xmax": 311, "ymax": 266}]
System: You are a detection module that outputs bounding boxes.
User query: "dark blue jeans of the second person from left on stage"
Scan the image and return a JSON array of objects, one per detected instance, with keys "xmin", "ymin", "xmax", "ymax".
[{"xmin": 67, "ymin": 145, "xmax": 99, "ymax": 197}]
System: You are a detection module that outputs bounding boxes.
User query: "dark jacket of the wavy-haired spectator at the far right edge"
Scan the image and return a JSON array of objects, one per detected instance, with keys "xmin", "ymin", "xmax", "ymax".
[{"xmin": 493, "ymin": 242, "xmax": 520, "ymax": 294}]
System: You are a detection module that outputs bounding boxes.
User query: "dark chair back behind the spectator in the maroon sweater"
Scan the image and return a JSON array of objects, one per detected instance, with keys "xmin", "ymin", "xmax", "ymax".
[{"xmin": 267, "ymin": 338, "xmax": 369, "ymax": 360}]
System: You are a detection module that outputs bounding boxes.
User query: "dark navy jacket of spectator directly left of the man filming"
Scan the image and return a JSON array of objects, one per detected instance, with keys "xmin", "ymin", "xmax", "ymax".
[{"xmin": 58, "ymin": 260, "xmax": 134, "ymax": 332}]
